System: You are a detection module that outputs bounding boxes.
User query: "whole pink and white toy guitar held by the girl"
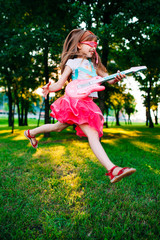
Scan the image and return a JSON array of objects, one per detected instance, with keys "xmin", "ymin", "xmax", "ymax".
[{"xmin": 65, "ymin": 66, "xmax": 147, "ymax": 98}]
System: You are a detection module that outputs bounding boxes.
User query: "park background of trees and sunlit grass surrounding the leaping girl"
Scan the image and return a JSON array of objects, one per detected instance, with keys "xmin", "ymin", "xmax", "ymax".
[{"xmin": 0, "ymin": 0, "xmax": 160, "ymax": 240}]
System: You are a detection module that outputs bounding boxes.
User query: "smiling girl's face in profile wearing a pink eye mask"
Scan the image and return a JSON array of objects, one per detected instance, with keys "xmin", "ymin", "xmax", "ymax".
[{"xmin": 78, "ymin": 41, "xmax": 97, "ymax": 58}]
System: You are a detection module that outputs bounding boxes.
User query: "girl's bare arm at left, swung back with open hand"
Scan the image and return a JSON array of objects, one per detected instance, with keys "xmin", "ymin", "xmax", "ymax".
[{"xmin": 42, "ymin": 66, "xmax": 72, "ymax": 98}]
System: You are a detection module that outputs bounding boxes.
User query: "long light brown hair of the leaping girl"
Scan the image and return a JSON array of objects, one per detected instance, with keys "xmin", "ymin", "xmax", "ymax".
[{"xmin": 60, "ymin": 29, "xmax": 107, "ymax": 77}]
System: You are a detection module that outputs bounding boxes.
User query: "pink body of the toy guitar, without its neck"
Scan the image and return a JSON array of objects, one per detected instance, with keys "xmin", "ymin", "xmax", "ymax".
[{"xmin": 65, "ymin": 76, "xmax": 105, "ymax": 98}]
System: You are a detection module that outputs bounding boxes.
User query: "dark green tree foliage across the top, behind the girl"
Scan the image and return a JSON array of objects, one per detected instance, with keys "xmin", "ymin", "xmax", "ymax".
[{"xmin": 0, "ymin": 0, "xmax": 160, "ymax": 127}]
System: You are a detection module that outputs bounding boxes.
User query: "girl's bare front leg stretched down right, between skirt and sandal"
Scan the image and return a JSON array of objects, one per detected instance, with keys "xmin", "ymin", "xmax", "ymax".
[{"xmin": 79, "ymin": 124, "xmax": 121, "ymax": 174}]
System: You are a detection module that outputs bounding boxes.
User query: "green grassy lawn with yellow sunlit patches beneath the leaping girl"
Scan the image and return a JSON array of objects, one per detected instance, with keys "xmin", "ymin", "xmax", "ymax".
[{"xmin": 0, "ymin": 119, "xmax": 160, "ymax": 240}]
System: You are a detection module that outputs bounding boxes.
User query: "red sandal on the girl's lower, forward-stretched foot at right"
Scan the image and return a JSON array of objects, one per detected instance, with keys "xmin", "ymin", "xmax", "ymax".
[{"xmin": 106, "ymin": 166, "xmax": 136, "ymax": 183}]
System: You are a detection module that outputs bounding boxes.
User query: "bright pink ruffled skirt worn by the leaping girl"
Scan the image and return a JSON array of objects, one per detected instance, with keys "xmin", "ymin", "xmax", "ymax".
[{"xmin": 50, "ymin": 95, "xmax": 104, "ymax": 137}]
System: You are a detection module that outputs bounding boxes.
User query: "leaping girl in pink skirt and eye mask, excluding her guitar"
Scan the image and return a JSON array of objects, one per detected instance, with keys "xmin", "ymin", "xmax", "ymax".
[{"xmin": 24, "ymin": 29, "xmax": 136, "ymax": 183}]
